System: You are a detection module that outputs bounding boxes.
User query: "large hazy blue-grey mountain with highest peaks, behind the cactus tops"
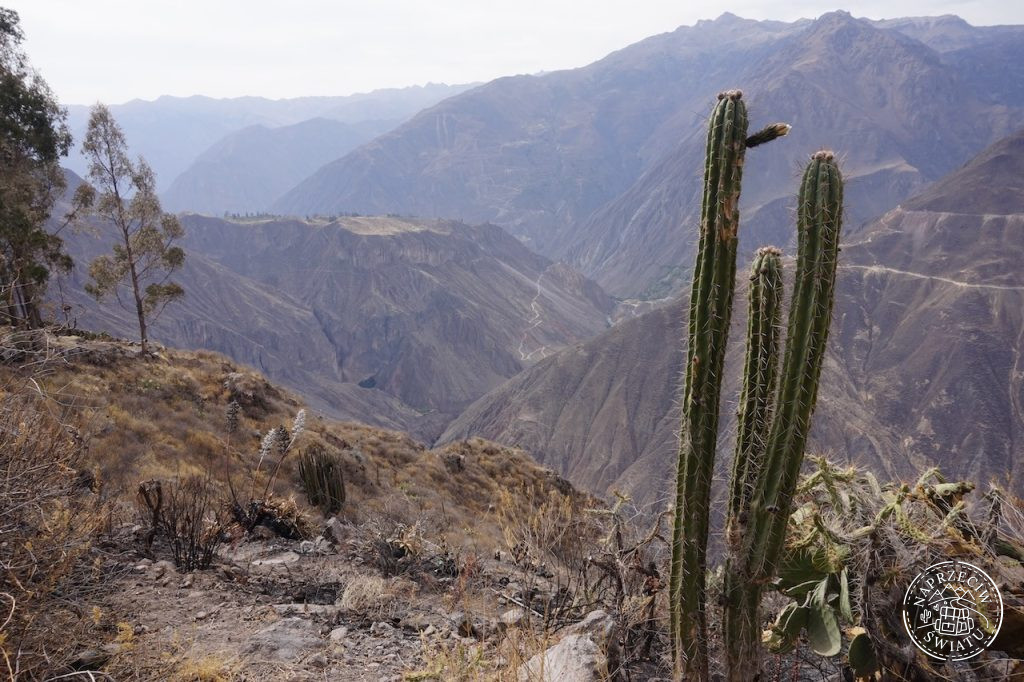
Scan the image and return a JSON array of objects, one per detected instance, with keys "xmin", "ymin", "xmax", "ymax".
[{"xmin": 271, "ymin": 12, "xmax": 1024, "ymax": 298}]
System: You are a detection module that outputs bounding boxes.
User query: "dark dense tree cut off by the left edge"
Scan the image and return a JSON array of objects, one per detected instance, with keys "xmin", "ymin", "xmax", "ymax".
[{"xmin": 0, "ymin": 7, "xmax": 72, "ymax": 327}]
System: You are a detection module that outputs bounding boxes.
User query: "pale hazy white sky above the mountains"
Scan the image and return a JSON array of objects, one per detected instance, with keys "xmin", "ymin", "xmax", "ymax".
[{"xmin": 8, "ymin": 0, "xmax": 1024, "ymax": 103}]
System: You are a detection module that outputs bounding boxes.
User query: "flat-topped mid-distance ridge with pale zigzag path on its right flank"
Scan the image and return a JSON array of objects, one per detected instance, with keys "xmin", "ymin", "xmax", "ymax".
[{"xmin": 62, "ymin": 206, "xmax": 612, "ymax": 439}]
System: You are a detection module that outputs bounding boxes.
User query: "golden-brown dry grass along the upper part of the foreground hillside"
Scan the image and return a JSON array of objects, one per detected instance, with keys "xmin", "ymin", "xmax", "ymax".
[{"xmin": 25, "ymin": 337, "xmax": 585, "ymax": 553}]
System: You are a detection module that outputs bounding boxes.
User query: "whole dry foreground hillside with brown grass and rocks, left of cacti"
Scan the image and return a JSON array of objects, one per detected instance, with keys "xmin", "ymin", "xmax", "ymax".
[{"xmin": 0, "ymin": 328, "xmax": 598, "ymax": 682}]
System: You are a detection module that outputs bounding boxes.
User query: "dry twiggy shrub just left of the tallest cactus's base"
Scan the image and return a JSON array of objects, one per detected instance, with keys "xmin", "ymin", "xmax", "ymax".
[{"xmin": 498, "ymin": 486, "xmax": 665, "ymax": 678}]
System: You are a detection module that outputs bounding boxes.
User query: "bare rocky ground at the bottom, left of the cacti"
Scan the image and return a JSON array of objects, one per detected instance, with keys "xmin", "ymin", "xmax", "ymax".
[{"xmin": 86, "ymin": 516, "xmax": 656, "ymax": 682}]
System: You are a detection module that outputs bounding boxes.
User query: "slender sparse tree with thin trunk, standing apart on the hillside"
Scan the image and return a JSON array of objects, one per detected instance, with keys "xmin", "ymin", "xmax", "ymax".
[{"xmin": 82, "ymin": 104, "xmax": 185, "ymax": 354}]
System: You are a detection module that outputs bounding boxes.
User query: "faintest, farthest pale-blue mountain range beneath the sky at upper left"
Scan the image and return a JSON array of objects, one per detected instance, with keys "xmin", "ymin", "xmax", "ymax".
[{"xmin": 66, "ymin": 83, "xmax": 472, "ymax": 191}]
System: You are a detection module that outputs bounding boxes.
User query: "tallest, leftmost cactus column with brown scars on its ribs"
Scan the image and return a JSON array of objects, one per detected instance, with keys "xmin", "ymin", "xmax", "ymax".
[{"xmin": 669, "ymin": 90, "xmax": 748, "ymax": 680}]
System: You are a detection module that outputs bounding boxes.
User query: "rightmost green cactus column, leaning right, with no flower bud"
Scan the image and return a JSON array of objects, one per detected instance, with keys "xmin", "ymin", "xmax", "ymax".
[{"xmin": 725, "ymin": 152, "xmax": 843, "ymax": 680}]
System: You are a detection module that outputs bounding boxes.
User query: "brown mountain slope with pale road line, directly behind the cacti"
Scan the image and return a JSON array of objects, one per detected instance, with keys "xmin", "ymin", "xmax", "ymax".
[{"xmin": 440, "ymin": 130, "xmax": 1024, "ymax": 504}]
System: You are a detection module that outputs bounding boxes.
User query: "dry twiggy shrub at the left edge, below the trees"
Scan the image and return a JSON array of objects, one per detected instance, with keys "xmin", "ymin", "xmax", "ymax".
[{"xmin": 0, "ymin": 386, "xmax": 101, "ymax": 679}]
